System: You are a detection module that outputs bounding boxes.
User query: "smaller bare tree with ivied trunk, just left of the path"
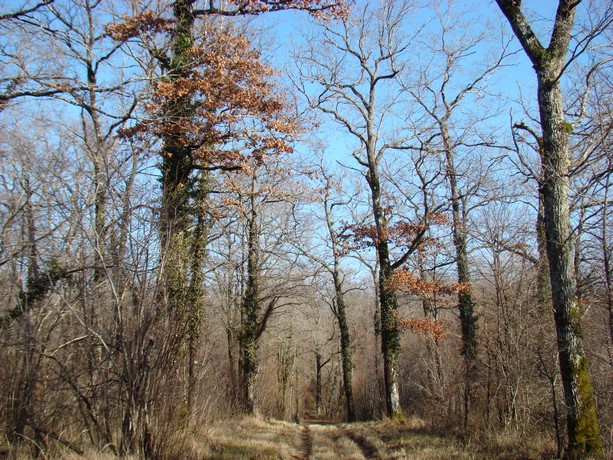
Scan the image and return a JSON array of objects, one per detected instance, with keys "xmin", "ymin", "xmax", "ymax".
[{"xmin": 213, "ymin": 155, "xmax": 304, "ymax": 414}]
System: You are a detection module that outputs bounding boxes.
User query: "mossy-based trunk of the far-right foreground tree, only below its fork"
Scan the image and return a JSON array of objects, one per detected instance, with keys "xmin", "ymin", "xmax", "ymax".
[{"xmin": 538, "ymin": 76, "xmax": 602, "ymax": 458}]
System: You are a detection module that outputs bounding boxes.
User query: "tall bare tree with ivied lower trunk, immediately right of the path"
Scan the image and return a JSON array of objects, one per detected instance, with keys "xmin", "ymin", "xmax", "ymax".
[{"xmin": 298, "ymin": 2, "xmax": 432, "ymax": 416}]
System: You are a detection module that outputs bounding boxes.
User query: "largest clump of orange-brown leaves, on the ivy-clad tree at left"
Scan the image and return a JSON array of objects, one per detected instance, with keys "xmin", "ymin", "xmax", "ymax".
[{"xmin": 123, "ymin": 27, "xmax": 298, "ymax": 167}]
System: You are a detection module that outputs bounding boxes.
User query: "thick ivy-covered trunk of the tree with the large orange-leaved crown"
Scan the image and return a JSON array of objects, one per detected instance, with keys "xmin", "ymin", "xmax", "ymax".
[{"xmin": 160, "ymin": 0, "xmax": 207, "ymax": 434}]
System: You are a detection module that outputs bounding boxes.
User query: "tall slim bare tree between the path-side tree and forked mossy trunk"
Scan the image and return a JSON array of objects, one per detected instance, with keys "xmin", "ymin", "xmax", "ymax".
[{"xmin": 396, "ymin": 3, "xmax": 509, "ymax": 425}]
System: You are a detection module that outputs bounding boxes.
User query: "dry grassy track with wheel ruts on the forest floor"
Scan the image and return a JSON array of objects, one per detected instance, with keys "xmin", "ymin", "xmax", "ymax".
[{"xmin": 193, "ymin": 418, "xmax": 552, "ymax": 460}]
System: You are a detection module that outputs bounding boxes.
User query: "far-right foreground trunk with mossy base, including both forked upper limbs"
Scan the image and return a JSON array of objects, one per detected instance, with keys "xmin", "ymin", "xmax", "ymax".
[{"xmin": 496, "ymin": 0, "xmax": 603, "ymax": 458}]
